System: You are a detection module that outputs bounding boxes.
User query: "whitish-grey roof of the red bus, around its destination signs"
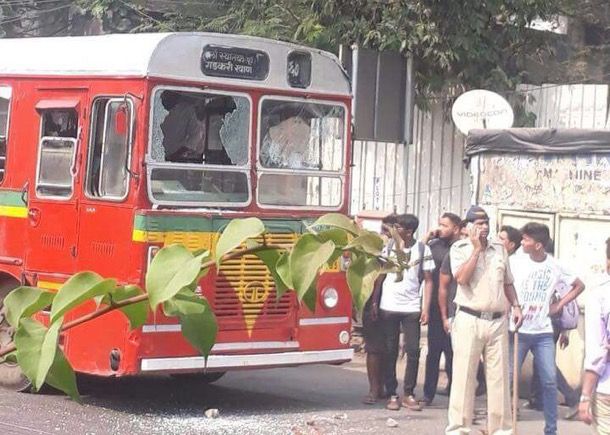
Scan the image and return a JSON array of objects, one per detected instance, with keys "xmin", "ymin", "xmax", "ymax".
[{"xmin": 0, "ymin": 33, "xmax": 351, "ymax": 95}]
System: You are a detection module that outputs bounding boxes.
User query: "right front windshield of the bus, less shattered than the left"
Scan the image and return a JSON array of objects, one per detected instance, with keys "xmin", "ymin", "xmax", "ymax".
[{"xmin": 258, "ymin": 97, "xmax": 346, "ymax": 209}]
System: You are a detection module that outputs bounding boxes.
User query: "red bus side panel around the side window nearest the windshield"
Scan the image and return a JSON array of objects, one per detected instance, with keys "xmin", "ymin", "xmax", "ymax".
[{"xmin": 66, "ymin": 79, "xmax": 150, "ymax": 376}]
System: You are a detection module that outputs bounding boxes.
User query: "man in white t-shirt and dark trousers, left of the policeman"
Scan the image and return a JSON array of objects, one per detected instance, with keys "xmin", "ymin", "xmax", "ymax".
[{"xmin": 379, "ymin": 214, "xmax": 434, "ymax": 411}]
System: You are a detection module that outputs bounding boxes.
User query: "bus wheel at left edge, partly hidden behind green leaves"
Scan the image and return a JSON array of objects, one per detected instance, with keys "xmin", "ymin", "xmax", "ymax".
[{"xmin": 0, "ymin": 277, "xmax": 32, "ymax": 391}]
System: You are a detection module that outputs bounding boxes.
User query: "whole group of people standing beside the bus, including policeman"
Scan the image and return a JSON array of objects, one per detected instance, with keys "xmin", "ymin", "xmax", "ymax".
[{"xmin": 356, "ymin": 206, "xmax": 610, "ymax": 435}]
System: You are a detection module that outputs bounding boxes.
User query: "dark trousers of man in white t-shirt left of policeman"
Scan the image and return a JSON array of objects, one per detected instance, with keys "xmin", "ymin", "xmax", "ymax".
[{"xmin": 380, "ymin": 310, "xmax": 421, "ymax": 396}]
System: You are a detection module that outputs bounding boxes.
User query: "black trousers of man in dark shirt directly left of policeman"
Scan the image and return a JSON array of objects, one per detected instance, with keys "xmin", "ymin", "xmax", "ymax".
[{"xmin": 424, "ymin": 313, "xmax": 453, "ymax": 400}]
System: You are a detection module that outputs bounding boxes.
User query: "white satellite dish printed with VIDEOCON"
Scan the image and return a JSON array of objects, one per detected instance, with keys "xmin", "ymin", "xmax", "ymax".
[{"xmin": 451, "ymin": 89, "xmax": 515, "ymax": 135}]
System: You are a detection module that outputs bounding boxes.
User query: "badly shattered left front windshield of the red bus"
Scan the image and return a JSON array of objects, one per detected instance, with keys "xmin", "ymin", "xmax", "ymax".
[{"xmin": 148, "ymin": 88, "xmax": 251, "ymax": 205}]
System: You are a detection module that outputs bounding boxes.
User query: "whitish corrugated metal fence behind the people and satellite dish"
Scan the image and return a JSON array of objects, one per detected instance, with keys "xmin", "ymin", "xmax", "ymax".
[{"xmin": 351, "ymin": 84, "xmax": 610, "ymax": 234}]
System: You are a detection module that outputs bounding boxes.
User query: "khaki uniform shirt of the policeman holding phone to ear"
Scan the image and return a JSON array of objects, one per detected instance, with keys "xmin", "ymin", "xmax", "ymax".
[{"xmin": 450, "ymin": 240, "xmax": 513, "ymax": 312}]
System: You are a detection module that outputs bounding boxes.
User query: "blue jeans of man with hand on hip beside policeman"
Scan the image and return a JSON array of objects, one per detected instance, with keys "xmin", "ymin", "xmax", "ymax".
[{"xmin": 510, "ymin": 332, "xmax": 557, "ymax": 435}]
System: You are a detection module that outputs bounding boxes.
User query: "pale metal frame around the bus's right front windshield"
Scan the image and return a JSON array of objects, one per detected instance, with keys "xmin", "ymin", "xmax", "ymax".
[{"xmin": 256, "ymin": 95, "xmax": 348, "ymax": 211}]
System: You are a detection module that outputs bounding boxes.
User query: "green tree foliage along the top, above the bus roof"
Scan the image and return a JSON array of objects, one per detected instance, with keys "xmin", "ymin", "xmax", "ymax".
[{"xmin": 0, "ymin": 0, "xmax": 580, "ymax": 95}]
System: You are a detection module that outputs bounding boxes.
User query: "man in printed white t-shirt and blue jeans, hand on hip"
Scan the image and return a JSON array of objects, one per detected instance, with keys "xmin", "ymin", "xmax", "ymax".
[{"xmin": 510, "ymin": 222, "xmax": 585, "ymax": 435}]
